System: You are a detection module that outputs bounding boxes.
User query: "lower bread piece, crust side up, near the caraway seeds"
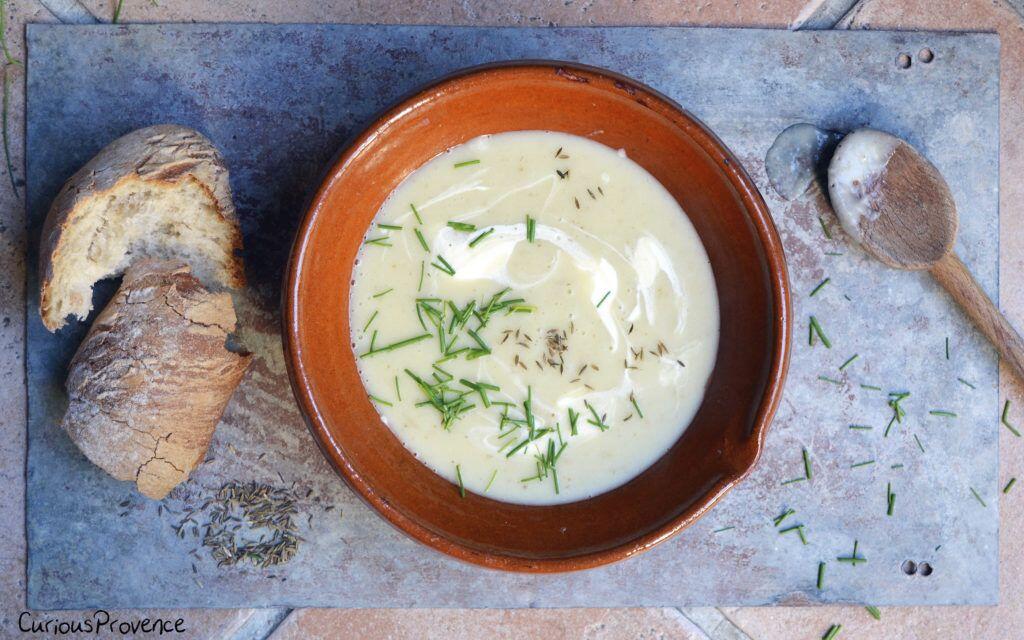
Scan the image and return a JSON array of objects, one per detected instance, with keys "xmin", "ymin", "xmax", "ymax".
[{"xmin": 62, "ymin": 260, "xmax": 252, "ymax": 500}]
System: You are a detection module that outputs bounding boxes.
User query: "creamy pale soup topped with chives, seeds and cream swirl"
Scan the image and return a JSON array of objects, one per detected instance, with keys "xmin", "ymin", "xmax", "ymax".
[{"xmin": 350, "ymin": 131, "xmax": 719, "ymax": 505}]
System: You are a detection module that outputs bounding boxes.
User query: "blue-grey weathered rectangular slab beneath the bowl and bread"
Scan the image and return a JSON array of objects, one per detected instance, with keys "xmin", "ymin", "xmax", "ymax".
[{"xmin": 27, "ymin": 25, "xmax": 999, "ymax": 608}]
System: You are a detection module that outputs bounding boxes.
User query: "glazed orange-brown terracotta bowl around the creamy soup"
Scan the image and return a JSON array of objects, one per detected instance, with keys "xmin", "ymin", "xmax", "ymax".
[{"xmin": 284, "ymin": 62, "xmax": 791, "ymax": 571}]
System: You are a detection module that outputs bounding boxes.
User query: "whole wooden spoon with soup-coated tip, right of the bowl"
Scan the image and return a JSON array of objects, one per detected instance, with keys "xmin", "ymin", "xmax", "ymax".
[{"xmin": 828, "ymin": 129, "xmax": 1024, "ymax": 380}]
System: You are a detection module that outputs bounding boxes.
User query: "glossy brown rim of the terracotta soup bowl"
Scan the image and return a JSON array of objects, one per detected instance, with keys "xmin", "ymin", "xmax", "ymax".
[{"xmin": 282, "ymin": 60, "xmax": 792, "ymax": 573}]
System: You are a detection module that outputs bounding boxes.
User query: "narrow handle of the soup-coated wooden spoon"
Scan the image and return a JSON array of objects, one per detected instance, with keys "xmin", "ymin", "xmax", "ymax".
[{"xmin": 932, "ymin": 251, "xmax": 1024, "ymax": 381}]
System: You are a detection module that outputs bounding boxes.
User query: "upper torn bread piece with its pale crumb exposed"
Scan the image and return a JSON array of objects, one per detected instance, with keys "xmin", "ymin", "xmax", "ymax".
[{"xmin": 39, "ymin": 125, "xmax": 245, "ymax": 331}]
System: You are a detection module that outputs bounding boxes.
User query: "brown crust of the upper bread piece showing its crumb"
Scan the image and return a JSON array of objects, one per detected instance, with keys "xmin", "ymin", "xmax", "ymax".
[{"xmin": 39, "ymin": 125, "xmax": 245, "ymax": 331}]
